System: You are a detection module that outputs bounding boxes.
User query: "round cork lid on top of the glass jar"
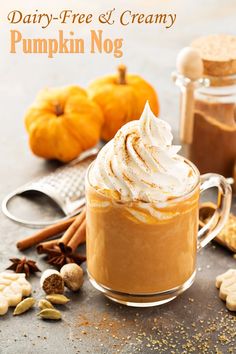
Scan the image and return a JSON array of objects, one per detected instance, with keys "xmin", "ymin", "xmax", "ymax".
[{"xmin": 191, "ymin": 35, "xmax": 236, "ymax": 76}]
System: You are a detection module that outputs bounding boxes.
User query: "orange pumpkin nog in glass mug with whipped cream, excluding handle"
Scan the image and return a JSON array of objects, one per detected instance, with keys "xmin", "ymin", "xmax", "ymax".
[{"xmin": 86, "ymin": 104, "xmax": 230, "ymax": 306}]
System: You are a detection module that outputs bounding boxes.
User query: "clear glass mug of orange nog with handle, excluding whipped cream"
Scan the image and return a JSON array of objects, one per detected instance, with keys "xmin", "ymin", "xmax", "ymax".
[{"xmin": 85, "ymin": 160, "xmax": 231, "ymax": 307}]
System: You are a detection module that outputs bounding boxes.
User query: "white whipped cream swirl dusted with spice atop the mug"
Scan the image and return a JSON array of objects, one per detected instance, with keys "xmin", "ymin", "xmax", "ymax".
[{"xmin": 90, "ymin": 103, "xmax": 197, "ymax": 202}]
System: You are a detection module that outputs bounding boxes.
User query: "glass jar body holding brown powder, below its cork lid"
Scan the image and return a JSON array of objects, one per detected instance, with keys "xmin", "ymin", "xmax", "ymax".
[{"xmin": 189, "ymin": 75, "xmax": 236, "ymax": 177}]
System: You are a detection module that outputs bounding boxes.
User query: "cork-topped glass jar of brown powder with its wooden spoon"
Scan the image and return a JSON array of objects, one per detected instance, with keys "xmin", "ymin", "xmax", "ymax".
[{"xmin": 173, "ymin": 34, "xmax": 236, "ymax": 177}]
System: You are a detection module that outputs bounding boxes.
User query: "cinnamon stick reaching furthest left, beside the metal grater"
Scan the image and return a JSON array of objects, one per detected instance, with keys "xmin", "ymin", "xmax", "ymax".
[{"xmin": 16, "ymin": 216, "xmax": 76, "ymax": 251}]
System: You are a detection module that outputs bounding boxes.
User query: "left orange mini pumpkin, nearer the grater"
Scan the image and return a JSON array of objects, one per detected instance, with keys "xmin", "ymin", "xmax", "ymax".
[{"xmin": 25, "ymin": 86, "xmax": 103, "ymax": 162}]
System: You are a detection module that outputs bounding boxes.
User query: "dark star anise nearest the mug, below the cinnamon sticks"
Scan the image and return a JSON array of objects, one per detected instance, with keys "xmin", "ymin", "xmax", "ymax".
[{"xmin": 47, "ymin": 249, "xmax": 86, "ymax": 268}]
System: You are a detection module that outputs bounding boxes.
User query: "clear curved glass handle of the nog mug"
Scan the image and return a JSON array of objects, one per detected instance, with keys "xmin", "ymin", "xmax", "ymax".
[{"xmin": 198, "ymin": 173, "xmax": 232, "ymax": 251}]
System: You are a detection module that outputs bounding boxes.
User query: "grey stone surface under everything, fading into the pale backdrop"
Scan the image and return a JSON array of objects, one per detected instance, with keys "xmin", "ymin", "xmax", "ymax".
[{"xmin": 0, "ymin": 0, "xmax": 236, "ymax": 354}]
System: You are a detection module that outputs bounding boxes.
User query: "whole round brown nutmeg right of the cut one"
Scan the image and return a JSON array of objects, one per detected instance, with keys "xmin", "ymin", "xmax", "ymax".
[{"xmin": 60, "ymin": 263, "xmax": 84, "ymax": 291}]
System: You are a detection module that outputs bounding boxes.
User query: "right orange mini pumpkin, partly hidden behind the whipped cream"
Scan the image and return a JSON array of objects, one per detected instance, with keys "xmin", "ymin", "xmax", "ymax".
[{"xmin": 88, "ymin": 65, "xmax": 159, "ymax": 141}]
